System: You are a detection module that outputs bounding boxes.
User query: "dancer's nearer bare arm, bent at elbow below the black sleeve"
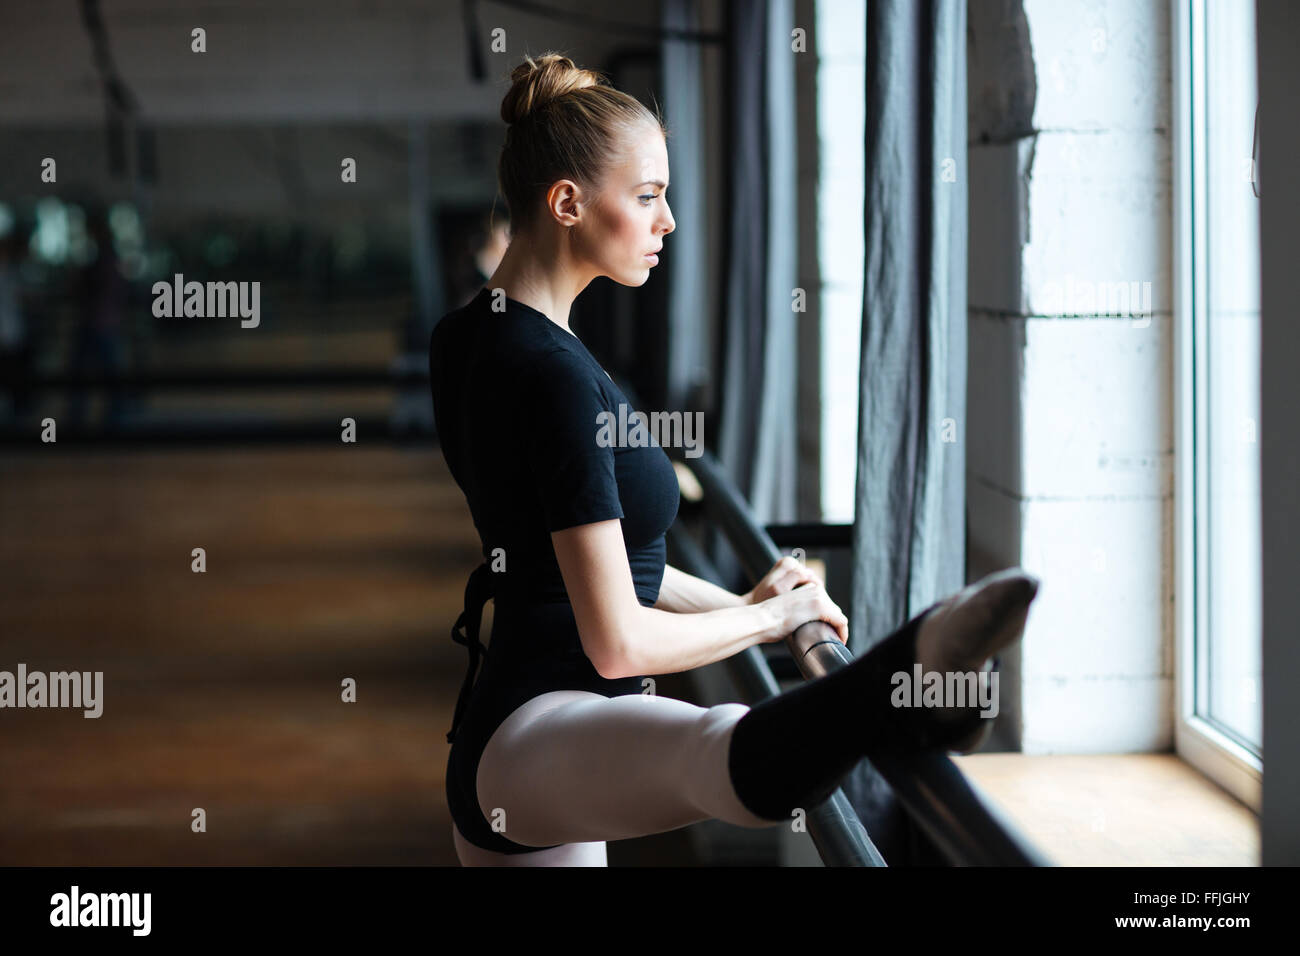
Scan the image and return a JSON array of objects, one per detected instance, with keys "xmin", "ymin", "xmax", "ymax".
[{"xmin": 551, "ymin": 520, "xmax": 846, "ymax": 680}]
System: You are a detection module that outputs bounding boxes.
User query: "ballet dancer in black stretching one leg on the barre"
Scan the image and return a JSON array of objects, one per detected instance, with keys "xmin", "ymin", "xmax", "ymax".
[{"xmin": 430, "ymin": 53, "xmax": 1037, "ymax": 866}]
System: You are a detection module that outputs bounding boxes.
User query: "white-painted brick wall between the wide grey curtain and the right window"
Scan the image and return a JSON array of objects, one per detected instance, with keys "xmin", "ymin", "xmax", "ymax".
[{"xmin": 967, "ymin": 0, "xmax": 1174, "ymax": 753}]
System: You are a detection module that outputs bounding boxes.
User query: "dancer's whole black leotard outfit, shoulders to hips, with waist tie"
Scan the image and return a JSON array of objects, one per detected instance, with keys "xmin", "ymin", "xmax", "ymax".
[{"xmin": 429, "ymin": 289, "xmax": 680, "ymax": 853}]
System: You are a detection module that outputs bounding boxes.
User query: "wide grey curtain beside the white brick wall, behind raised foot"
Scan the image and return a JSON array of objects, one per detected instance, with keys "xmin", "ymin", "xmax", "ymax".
[{"xmin": 845, "ymin": 0, "xmax": 966, "ymax": 865}]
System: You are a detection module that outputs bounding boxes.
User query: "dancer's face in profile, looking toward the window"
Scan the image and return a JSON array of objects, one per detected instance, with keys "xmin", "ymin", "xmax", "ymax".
[{"xmin": 572, "ymin": 126, "xmax": 677, "ymax": 286}]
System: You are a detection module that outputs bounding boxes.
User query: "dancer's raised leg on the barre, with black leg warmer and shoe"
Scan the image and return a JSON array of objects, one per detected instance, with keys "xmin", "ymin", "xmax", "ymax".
[{"xmin": 462, "ymin": 570, "xmax": 1037, "ymax": 865}]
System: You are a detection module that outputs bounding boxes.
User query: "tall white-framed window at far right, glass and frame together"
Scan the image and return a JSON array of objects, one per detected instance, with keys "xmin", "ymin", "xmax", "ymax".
[{"xmin": 1174, "ymin": 0, "xmax": 1262, "ymax": 810}]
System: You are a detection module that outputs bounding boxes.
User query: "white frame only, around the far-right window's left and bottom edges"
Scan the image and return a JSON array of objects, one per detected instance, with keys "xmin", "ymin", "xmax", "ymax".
[{"xmin": 1170, "ymin": 0, "xmax": 1262, "ymax": 813}]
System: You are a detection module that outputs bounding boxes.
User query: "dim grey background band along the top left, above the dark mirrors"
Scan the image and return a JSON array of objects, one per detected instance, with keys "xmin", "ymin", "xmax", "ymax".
[{"xmin": 0, "ymin": 0, "xmax": 659, "ymax": 127}]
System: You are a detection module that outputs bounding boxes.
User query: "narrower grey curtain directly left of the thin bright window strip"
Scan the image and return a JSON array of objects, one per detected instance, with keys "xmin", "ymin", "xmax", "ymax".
[{"xmin": 711, "ymin": 0, "xmax": 798, "ymax": 589}]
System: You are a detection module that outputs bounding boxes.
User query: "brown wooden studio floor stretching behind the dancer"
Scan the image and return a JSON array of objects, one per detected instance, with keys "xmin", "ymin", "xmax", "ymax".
[{"xmin": 0, "ymin": 444, "xmax": 693, "ymax": 866}]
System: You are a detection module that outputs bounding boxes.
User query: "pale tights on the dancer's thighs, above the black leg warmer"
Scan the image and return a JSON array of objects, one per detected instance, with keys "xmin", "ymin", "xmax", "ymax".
[{"xmin": 452, "ymin": 691, "xmax": 781, "ymax": 866}]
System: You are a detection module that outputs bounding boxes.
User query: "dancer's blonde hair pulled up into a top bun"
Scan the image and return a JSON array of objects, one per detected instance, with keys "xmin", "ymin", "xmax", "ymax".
[{"xmin": 497, "ymin": 53, "xmax": 668, "ymax": 232}]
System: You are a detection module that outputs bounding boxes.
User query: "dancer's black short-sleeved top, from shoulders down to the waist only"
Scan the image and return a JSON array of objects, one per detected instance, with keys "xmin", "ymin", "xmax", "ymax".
[{"xmin": 429, "ymin": 289, "xmax": 680, "ymax": 606}]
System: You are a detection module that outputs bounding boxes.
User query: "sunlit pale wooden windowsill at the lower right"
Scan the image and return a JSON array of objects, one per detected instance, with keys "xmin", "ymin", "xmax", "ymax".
[{"xmin": 953, "ymin": 753, "xmax": 1260, "ymax": 866}]
